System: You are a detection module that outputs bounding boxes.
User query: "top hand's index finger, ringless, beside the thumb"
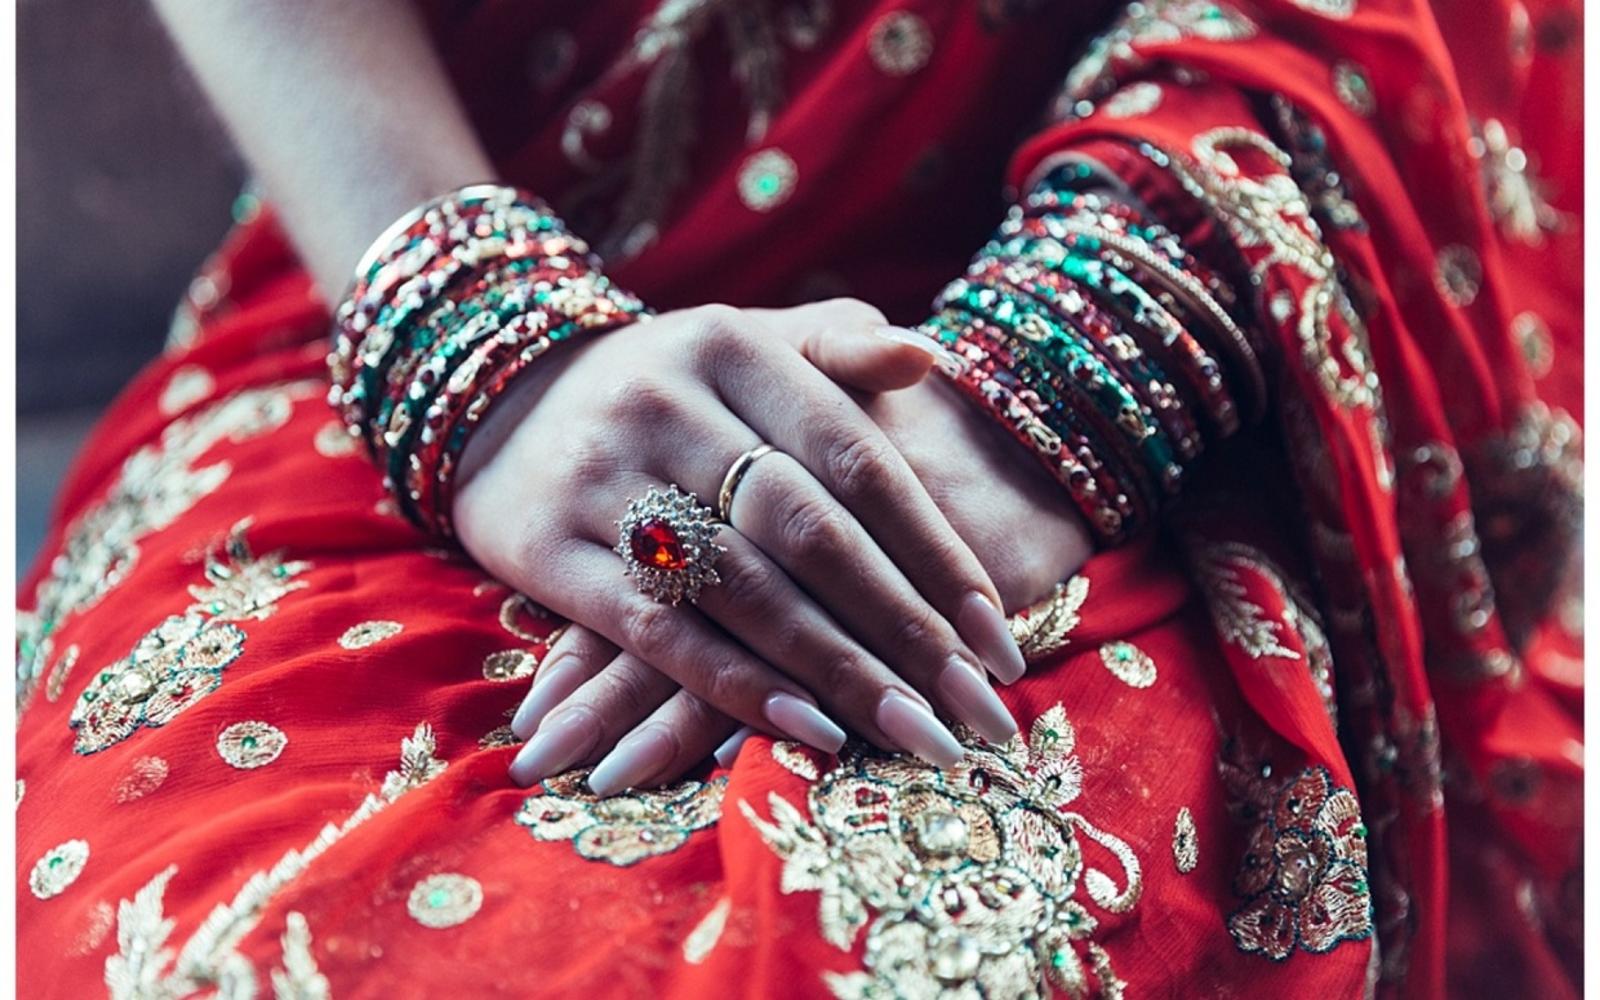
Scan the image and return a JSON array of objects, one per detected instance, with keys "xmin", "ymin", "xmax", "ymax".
[{"xmin": 699, "ymin": 309, "xmax": 1026, "ymax": 683}]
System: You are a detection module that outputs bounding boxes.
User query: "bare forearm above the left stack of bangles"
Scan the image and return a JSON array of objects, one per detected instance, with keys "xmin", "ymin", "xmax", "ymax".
[{"xmin": 152, "ymin": 0, "xmax": 493, "ymax": 299}]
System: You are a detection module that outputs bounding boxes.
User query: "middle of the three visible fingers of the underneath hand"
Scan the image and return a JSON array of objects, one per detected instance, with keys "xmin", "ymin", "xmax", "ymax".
[{"xmin": 510, "ymin": 653, "xmax": 678, "ymax": 787}]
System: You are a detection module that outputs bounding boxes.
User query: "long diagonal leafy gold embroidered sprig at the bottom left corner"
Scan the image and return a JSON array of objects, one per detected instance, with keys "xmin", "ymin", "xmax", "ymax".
[{"xmin": 106, "ymin": 723, "xmax": 445, "ymax": 1000}]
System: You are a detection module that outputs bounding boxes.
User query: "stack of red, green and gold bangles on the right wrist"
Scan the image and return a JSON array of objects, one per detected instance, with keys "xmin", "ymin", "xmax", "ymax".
[{"xmin": 922, "ymin": 168, "xmax": 1266, "ymax": 546}]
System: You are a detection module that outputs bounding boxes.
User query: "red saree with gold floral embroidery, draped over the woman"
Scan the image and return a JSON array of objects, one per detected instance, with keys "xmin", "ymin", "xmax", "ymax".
[{"xmin": 18, "ymin": 0, "xmax": 1582, "ymax": 998}]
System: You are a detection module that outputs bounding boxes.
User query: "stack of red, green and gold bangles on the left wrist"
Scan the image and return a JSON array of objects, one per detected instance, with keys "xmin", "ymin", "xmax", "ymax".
[{"xmin": 328, "ymin": 184, "xmax": 648, "ymax": 536}]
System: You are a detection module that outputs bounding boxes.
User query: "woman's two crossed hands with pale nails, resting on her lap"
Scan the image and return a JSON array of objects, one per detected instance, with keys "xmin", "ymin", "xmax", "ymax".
[{"xmin": 453, "ymin": 299, "xmax": 1090, "ymax": 795}]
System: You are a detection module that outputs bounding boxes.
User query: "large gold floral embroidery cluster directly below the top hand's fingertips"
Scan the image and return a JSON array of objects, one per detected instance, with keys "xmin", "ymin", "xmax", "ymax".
[{"xmin": 739, "ymin": 706, "xmax": 1144, "ymax": 997}]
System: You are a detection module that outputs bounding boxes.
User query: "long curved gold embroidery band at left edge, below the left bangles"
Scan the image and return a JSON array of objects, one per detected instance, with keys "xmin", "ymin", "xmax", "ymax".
[{"xmin": 16, "ymin": 381, "xmax": 320, "ymax": 710}]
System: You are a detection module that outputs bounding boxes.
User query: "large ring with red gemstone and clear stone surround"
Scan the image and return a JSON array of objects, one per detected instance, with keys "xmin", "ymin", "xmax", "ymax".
[{"xmin": 614, "ymin": 483, "xmax": 726, "ymax": 605}]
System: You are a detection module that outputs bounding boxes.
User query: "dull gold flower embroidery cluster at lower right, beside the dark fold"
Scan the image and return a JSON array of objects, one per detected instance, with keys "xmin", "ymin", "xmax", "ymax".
[{"xmin": 1219, "ymin": 746, "xmax": 1373, "ymax": 960}]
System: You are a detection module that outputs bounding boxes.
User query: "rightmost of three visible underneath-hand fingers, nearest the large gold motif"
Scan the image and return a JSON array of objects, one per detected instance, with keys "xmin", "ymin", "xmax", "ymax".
[{"xmin": 589, "ymin": 690, "xmax": 739, "ymax": 797}]
